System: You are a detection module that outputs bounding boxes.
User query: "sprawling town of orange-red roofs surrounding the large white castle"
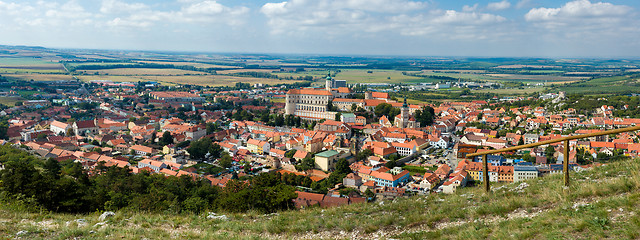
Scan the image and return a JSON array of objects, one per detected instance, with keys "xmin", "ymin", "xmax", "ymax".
[{"xmin": 0, "ymin": 76, "xmax": 640, "ymax": 208}]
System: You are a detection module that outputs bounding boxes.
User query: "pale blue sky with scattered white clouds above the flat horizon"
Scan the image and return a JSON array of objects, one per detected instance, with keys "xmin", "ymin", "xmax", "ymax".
[{"xmin": 0, "ymin": 0, "xmax": 640, "ymax": 58}]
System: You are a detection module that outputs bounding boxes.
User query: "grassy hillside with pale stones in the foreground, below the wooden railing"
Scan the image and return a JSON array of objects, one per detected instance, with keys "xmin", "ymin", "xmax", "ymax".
[{"xmin": 0, "ymin": 159, "xmax": 640, "ymax": 239}]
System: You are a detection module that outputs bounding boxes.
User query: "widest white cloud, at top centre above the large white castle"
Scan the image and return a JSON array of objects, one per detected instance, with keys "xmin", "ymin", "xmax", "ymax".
[{"xmin": 261, "ymin": 0, "xmax": 506, "ymax": 39}]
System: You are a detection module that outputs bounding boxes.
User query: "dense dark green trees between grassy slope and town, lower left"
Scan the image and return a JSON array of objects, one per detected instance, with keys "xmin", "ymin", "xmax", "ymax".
[{"xmin": 0, "ymin": 146, "xmax": 298, "ymax": 213}]
